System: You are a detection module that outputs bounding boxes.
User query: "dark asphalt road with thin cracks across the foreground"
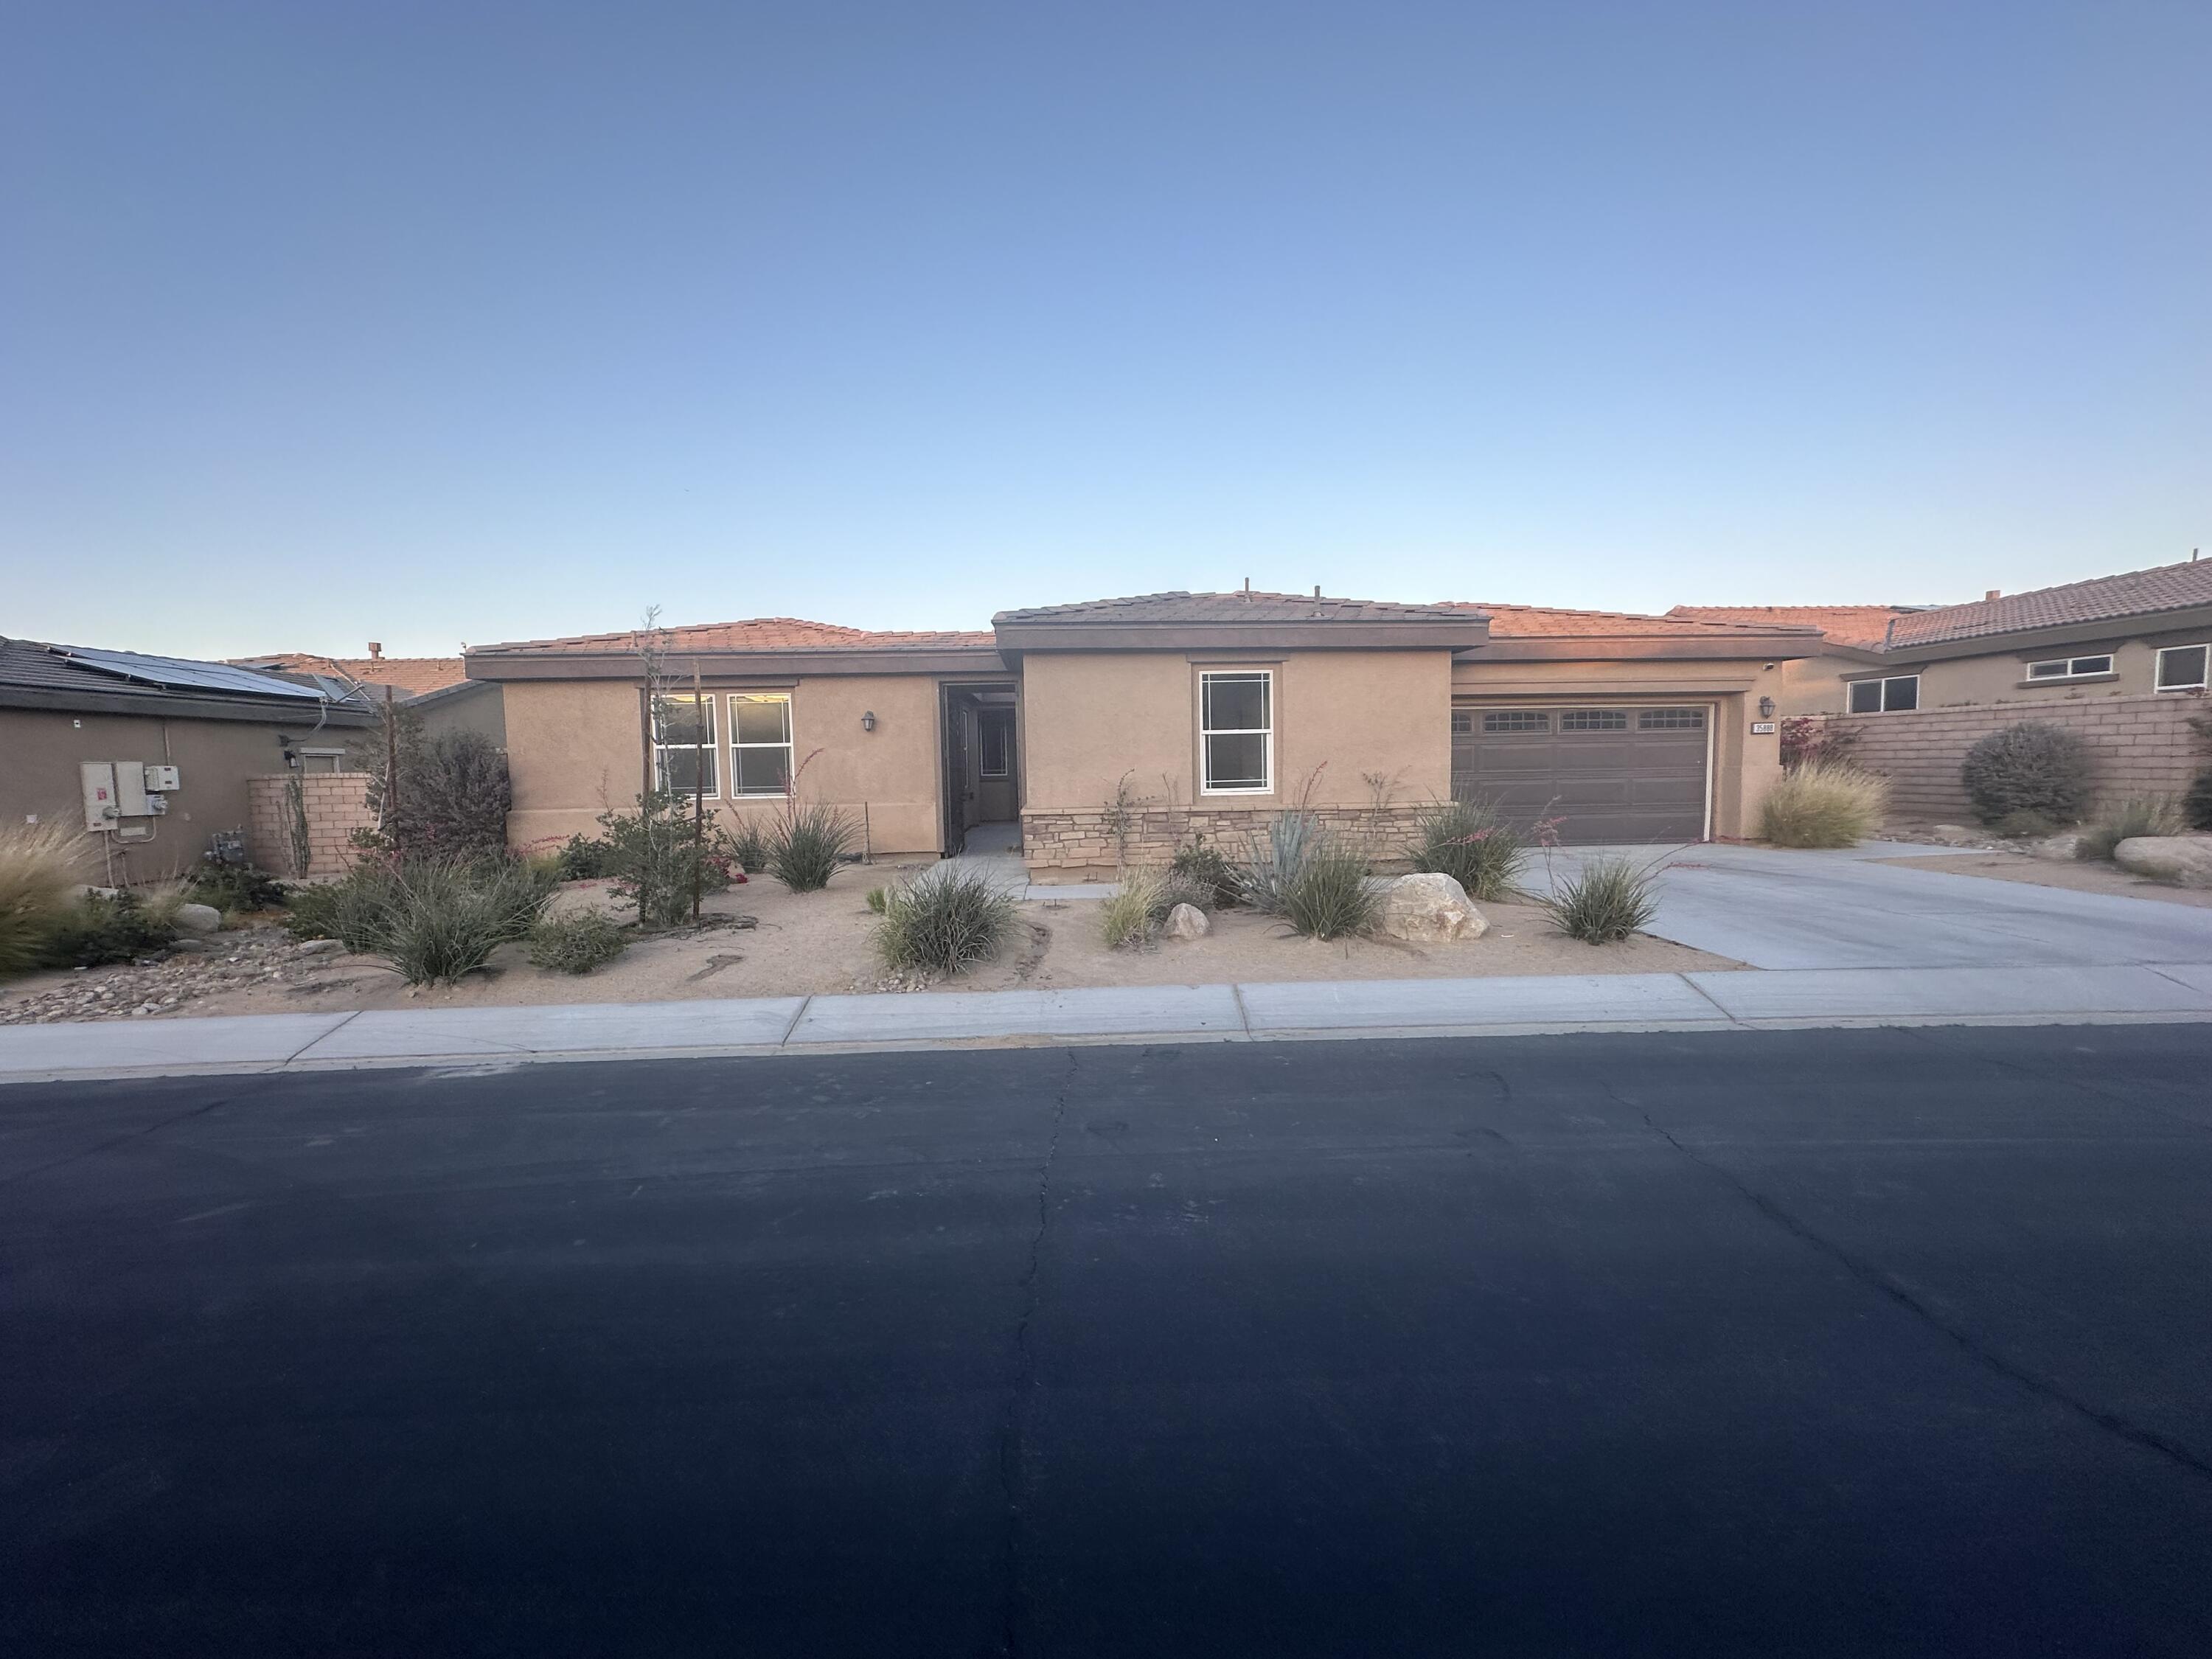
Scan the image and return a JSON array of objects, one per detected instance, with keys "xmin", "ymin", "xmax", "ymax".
[{"xmin": 0, "ymin": 1026, "xmax": 2212, "ymax": 1659}]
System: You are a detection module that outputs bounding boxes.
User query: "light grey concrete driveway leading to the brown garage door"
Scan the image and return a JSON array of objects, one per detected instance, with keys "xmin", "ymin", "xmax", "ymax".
[{"xmin": 1531, "ymin": 841, "xmax": 2212, "ymax": 969}]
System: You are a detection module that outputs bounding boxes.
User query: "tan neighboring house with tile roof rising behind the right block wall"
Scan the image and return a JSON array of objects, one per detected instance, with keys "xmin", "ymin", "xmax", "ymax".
[{"xmin": 1668, "ymin": 560, "xmax": 2212, "ymax": 714}]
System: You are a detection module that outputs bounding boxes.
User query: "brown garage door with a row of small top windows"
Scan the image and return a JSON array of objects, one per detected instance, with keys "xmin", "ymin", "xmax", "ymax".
[{"xmin": 1451, "ymin": 703, "xmax": 1712, "ymax": 847}]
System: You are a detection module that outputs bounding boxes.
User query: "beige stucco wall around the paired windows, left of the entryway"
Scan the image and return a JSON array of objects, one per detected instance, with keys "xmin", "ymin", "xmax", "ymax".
[{"xmin": 504, "ymin": 675, "xmax": 940, "ymax": 854}]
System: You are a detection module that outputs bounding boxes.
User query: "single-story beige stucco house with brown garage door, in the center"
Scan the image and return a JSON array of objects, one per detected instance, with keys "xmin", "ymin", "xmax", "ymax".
[{"xmin": 467, "ymin": 591, "xmax": 1820, "ymax": 872}]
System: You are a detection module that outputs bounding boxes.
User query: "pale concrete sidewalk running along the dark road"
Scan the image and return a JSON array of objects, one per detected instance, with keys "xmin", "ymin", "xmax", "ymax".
[{"xmin": 0, "ymin": 962, "xmax": 2212, "ymax": 1082}]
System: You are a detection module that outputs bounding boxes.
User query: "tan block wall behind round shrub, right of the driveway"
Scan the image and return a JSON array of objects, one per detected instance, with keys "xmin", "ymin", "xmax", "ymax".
[{"xmin": 1827, "ymin": 695, "xmax": 2212, "ymax": 823}]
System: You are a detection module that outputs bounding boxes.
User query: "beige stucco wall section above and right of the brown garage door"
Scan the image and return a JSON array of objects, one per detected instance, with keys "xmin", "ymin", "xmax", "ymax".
[{"xmin": 1451, "ymin": 659, "xmax": 1790, "ymax": 838}]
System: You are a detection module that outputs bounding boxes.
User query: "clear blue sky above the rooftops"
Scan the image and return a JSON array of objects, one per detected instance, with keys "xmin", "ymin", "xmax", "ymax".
[{"xmin": 0, "ymin": 0, "xmax": 2212, "ymax": 655}]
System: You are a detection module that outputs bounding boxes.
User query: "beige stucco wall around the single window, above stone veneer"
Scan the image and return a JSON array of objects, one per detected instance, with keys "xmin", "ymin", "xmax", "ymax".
[{"xmin": 1022, "ymin": 650, "xmax": 1451, "ymax": 814}]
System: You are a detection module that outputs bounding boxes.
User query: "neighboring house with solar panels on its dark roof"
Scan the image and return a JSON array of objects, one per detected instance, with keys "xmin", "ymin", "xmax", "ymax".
[{"xmin": 0, "ymin": 639, "xmax": 372, "ymax": 883}]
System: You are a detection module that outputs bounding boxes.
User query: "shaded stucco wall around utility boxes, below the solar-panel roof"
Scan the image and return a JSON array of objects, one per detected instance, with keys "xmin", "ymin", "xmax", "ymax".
[{"xmin": 0, "ymin": 708, "xmax": 356, "ymax": 883}]
